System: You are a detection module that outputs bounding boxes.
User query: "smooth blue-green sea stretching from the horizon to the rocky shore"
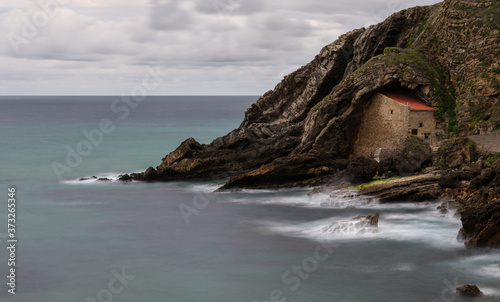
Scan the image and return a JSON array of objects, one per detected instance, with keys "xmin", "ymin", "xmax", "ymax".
[{"xmin": 0, "ymin": 96, "xmax": 500, "ymax": 302}]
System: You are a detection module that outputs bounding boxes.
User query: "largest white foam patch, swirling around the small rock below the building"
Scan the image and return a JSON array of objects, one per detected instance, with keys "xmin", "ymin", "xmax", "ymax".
[{"xmin": 242, "ymin": 190, "xmax": 463, "ymax": 249}]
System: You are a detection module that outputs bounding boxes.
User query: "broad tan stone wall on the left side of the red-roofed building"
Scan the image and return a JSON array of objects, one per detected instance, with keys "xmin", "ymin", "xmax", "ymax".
[{"xmin": 353, "ymin": 93, "xmax": 410, "ymax": 158}]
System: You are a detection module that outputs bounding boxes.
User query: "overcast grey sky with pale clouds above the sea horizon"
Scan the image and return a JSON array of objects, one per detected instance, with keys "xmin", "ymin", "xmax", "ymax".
[{"xmin": 0, "ymin": 0, "xmax": 439, "ymax": 95}]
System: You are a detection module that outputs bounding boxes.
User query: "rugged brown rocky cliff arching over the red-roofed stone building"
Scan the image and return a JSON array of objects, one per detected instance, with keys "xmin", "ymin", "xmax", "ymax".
[{"xmin": 132, "ymin": 0, "xmax": 500, "ymax": 188}]
